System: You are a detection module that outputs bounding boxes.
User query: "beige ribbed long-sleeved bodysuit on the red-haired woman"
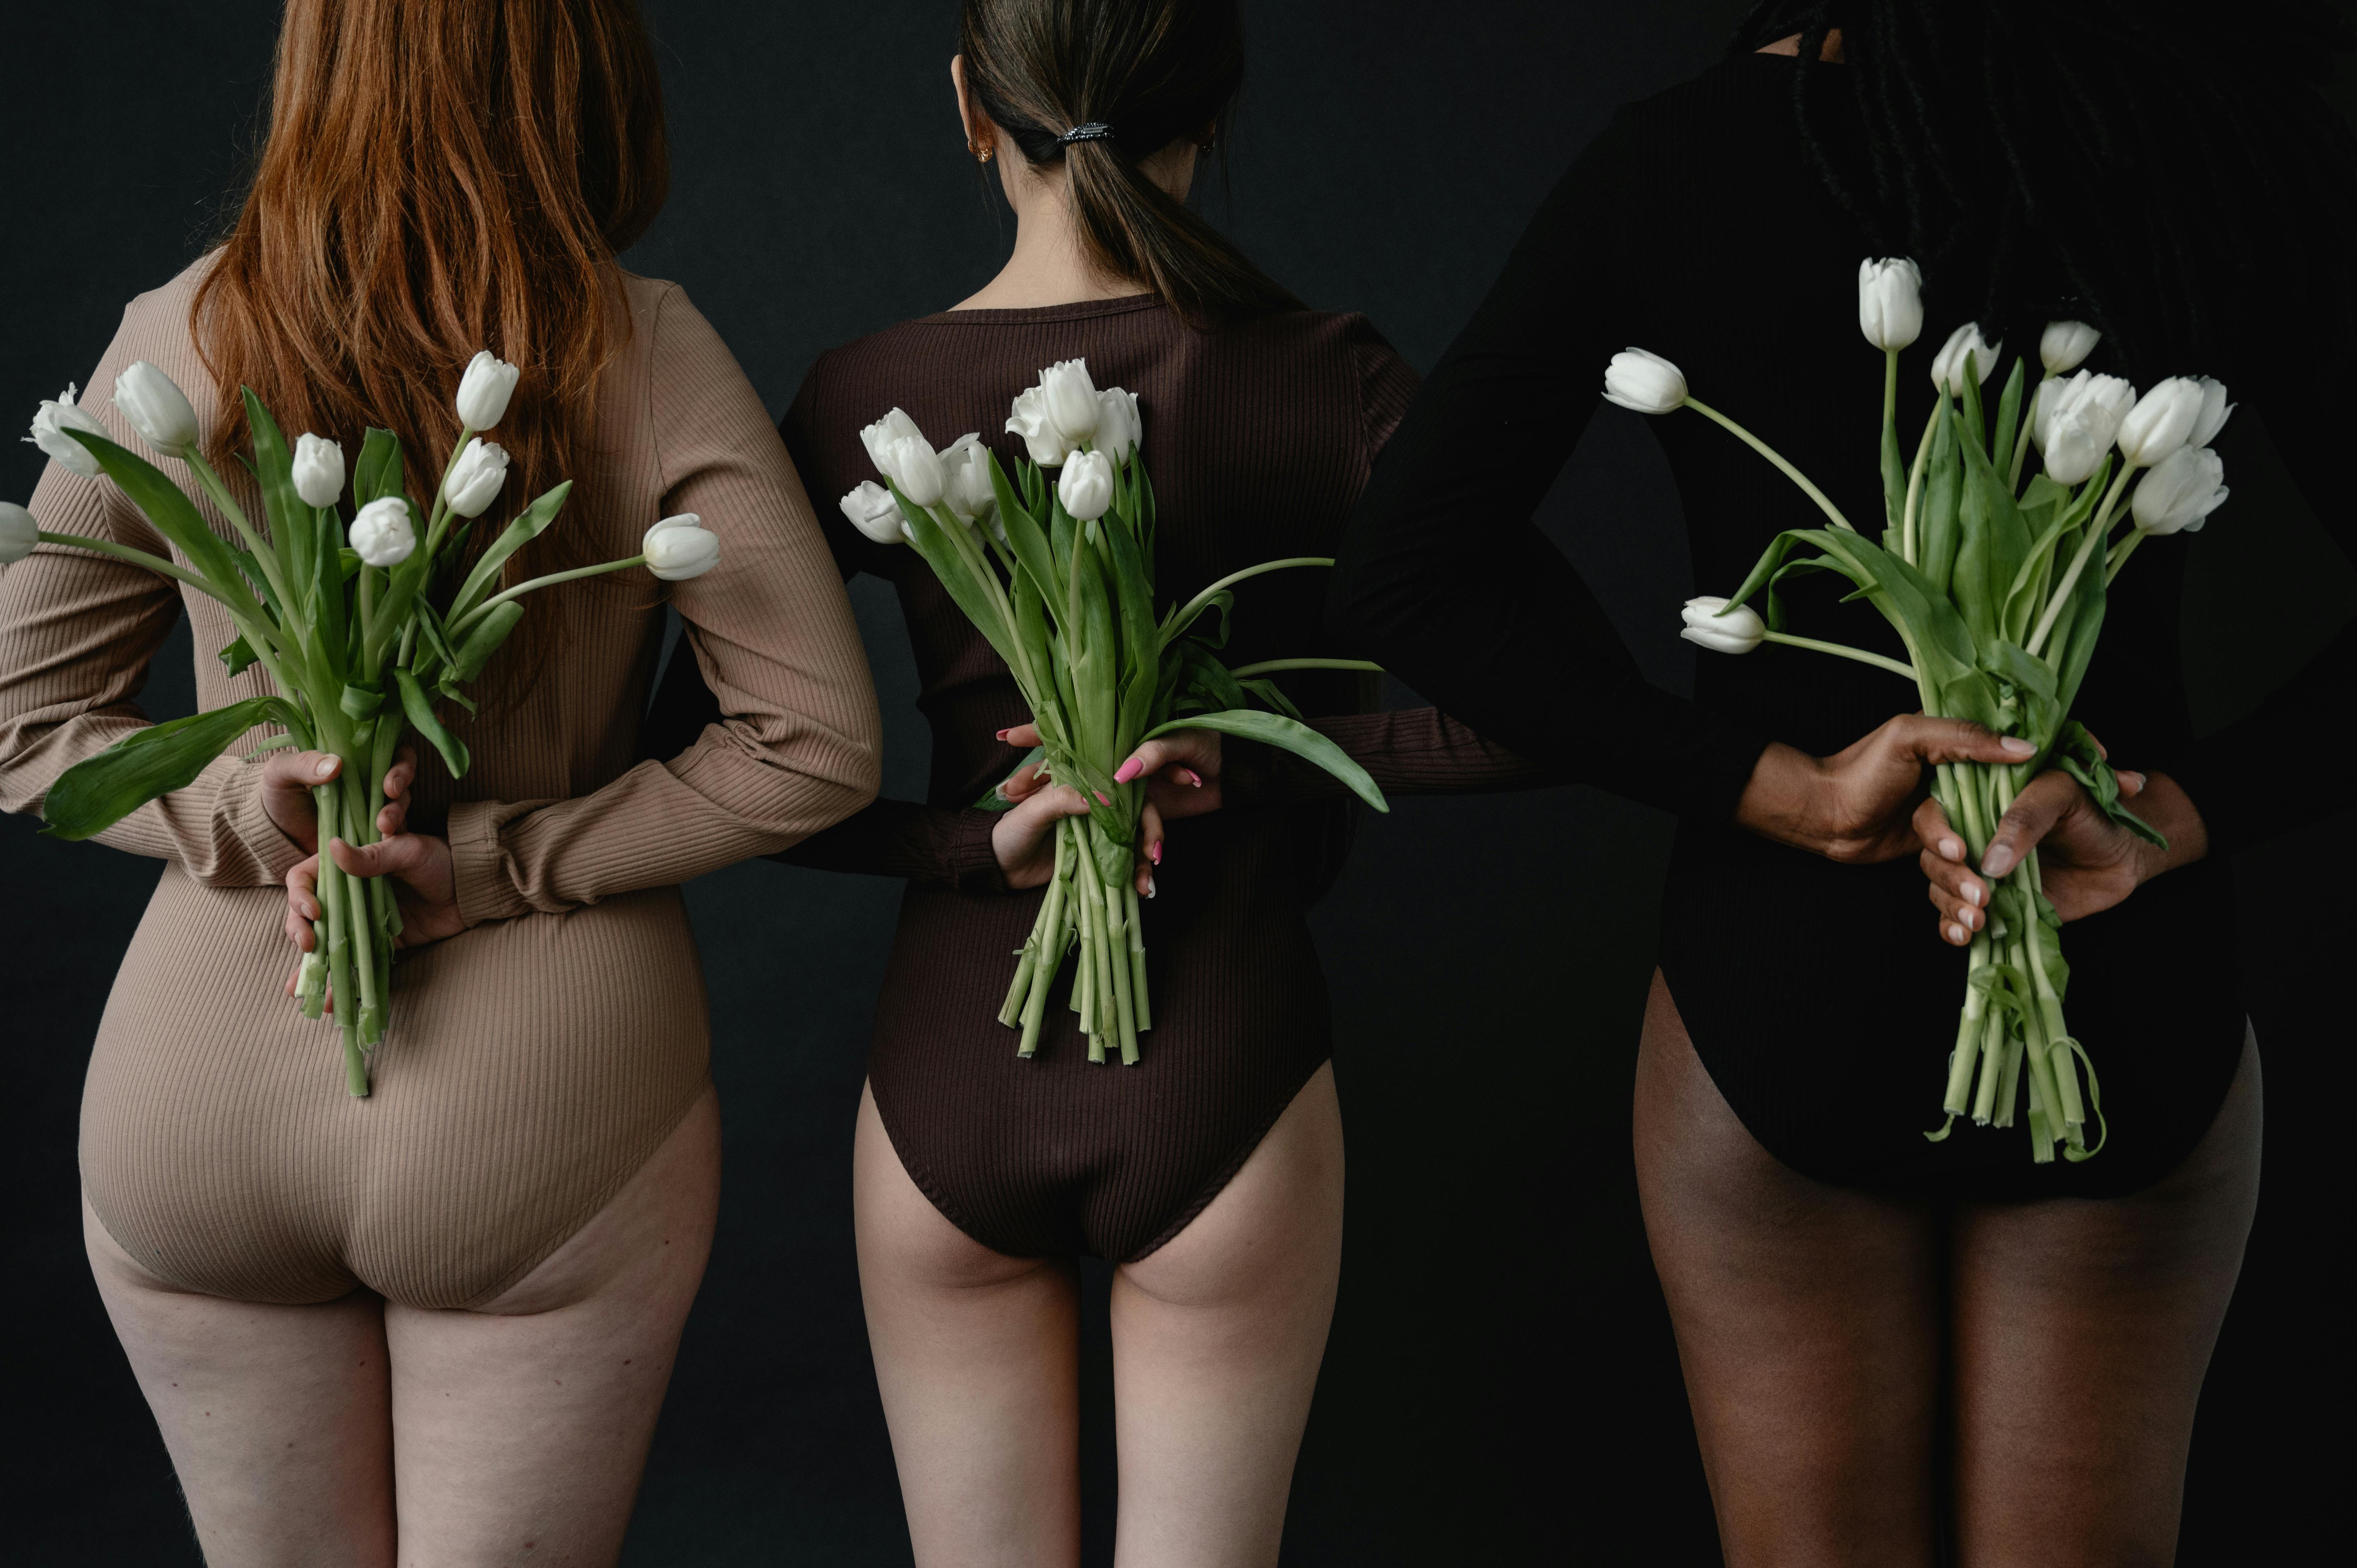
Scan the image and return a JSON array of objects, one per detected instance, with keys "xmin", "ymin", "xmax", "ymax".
[{"xmin": 0, "ymin": 262, "xmax": 877, "ymax": 1306}]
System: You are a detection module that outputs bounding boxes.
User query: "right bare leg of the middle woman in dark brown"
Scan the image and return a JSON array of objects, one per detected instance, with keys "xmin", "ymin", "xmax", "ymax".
[{"xmin": 1113, "ymin": 1063, "xmax": 1344, "ymax": 1568}]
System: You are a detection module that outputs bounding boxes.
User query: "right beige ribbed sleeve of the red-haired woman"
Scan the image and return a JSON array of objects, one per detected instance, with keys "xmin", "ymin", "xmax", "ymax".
[{"xmin": 450, "ymin": 290, "xmax": 879, "ymax": 924}]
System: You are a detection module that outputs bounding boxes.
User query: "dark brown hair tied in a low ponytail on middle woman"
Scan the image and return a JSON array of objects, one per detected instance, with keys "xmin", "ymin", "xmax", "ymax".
[{"xmin": 959, "ymin": 0, "xmax": 1303, "ymax": 328}]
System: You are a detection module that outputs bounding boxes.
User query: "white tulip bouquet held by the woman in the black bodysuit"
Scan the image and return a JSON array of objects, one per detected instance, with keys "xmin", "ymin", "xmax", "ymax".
[{"xmin": 1605, "ymin": 259, "xmax": 2232, "ymax": 1163}]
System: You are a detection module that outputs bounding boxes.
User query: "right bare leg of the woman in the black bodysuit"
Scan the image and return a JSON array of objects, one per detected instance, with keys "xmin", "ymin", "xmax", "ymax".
[{"xmin": 1956, "ymin": 1042, "xmax": 2263, "ymax": 1568}]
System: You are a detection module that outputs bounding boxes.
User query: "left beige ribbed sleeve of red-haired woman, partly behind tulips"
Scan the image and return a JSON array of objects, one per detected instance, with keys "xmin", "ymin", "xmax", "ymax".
[{"xmin": 0, "ymin": 295, "xmax": 304, "ymax": 887}]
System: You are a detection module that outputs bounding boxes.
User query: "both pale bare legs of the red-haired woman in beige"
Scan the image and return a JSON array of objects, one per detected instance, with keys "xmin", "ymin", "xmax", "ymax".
[{"xmin": 82, "ymin": 1089, "xmax": 721, "ymax": 1568}]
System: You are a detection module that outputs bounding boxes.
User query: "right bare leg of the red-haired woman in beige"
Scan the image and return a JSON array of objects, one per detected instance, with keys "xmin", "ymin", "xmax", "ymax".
[{"xmin": 384, "ymin": 1089, "xmax": 721, "ymax": 1568}]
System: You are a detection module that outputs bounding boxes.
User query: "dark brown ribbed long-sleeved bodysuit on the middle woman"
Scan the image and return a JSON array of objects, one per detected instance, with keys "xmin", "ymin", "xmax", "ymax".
[{"xmin": 688, "ymin": 297, "xmax": 1530, "ymax": 1259}]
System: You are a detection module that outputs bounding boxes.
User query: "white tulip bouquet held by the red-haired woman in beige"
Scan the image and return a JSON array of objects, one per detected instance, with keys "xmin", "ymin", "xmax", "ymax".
[{"xmin": 0, "ymin": 351, "xmax": 719, "ymax": 1094}]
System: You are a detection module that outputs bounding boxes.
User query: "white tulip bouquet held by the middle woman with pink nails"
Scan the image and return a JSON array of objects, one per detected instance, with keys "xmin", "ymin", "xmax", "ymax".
[{"xmin": 841, "ymin": 358, "xmax": 1388, "ymax": 1063}]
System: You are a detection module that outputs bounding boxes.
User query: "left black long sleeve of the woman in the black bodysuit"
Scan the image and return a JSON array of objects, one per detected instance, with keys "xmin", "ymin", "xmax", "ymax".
[{"xmin": 1330, "ymin": 139, "xmax": 1768, "ymax": 820}]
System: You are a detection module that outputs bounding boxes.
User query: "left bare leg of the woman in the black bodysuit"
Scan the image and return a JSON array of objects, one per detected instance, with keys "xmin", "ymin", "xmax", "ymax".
[{"xmin": 1636, "ymin": 974, "xmax": 1940, "ymax": 1568}]
